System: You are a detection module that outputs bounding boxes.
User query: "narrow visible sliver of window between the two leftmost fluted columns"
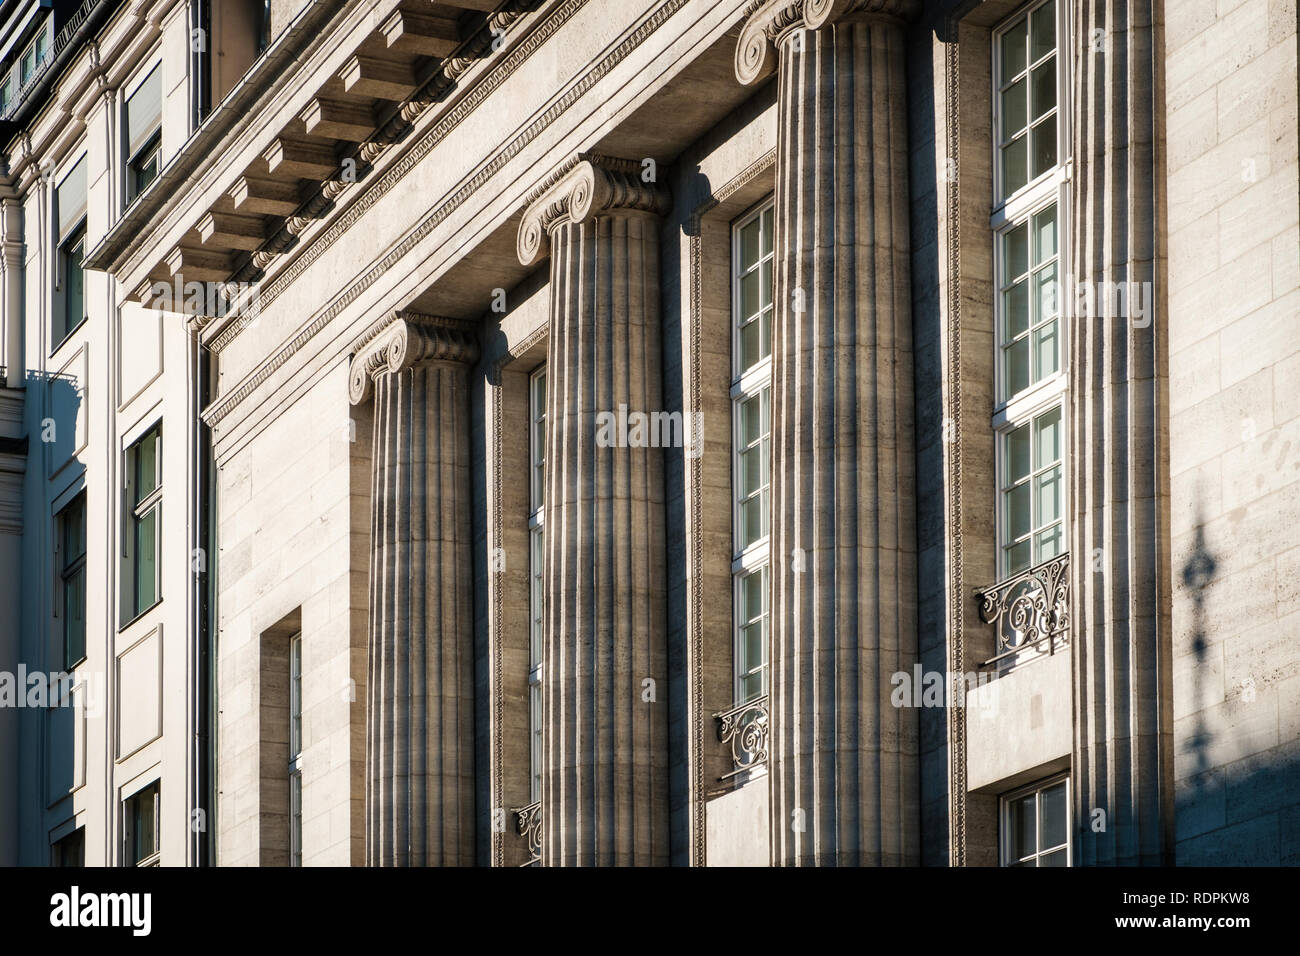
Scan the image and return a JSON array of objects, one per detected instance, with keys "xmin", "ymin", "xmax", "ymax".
[{"xmin": 528, "ymin": 365, "xmax": 546, "ymax": 804}]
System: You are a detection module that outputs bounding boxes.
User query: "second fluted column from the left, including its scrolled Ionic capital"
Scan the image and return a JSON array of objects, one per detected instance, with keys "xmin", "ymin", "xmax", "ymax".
[{"xmin": 519, "ymin": 156, "xmax": 668, "ymax": 866}]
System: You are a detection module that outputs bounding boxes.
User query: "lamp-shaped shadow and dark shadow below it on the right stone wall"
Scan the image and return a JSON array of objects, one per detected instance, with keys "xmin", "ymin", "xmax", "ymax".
[{"xmin": 1175, "ymin": 514, "xmax": 1300, "ymax": 866}]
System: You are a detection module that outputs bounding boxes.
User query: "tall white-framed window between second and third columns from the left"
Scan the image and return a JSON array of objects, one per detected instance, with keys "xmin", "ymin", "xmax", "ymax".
[{"xmin": 731, "ymin": 200, "xmax": 774, "ymax": 704}]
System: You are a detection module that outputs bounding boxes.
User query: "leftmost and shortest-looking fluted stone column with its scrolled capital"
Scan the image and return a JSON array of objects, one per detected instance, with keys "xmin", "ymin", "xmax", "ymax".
[{"xmin": 348, "ymin": 315, "xmax": 478, "ymax": 866}]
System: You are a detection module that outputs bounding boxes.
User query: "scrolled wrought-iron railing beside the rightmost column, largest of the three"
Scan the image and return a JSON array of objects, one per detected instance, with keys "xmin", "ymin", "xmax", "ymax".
[{"xmin": 975, "ymin": 553, "xmax": 1070, "ymax": 667}]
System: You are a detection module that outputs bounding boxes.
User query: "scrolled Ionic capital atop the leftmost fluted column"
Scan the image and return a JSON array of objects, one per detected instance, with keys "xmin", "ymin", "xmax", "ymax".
[{"xmin": 347, "ymin": 312, "xmax": 478, "ymax": 405}]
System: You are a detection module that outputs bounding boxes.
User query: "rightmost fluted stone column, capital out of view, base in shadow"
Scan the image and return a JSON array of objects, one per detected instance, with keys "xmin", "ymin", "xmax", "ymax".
[{"xmin": 1070, "ymin": 0, "xmax": 1174, "ymax": 866}]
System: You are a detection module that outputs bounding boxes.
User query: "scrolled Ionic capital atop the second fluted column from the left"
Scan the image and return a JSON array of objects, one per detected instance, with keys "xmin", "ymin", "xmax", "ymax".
[{"xmin": 516, "ymin": 152, "xmax": 670, "ymax": 265}]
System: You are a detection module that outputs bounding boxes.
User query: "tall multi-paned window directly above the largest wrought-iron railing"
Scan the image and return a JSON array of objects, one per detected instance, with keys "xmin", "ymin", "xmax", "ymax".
[{"xmin": 992, "ymin": 0, "xmax": 1070, "ymax": 579}]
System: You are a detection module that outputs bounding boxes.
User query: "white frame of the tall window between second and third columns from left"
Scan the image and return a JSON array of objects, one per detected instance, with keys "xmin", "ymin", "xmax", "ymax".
[{"xmin": 731, "ymin": 195, "xmax": 776, "ymax": 705}]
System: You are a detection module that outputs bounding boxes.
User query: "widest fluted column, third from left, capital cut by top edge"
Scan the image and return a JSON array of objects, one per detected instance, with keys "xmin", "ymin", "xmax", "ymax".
[{"xmin": 736, "ymin": 0, "xmax": 919, "ymax": 865}]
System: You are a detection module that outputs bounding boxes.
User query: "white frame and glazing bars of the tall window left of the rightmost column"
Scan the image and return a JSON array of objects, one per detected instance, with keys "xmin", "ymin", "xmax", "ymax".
[{"xmin": 989, "ymin": 0, "xmax": 1073, "ymax": 580}]
